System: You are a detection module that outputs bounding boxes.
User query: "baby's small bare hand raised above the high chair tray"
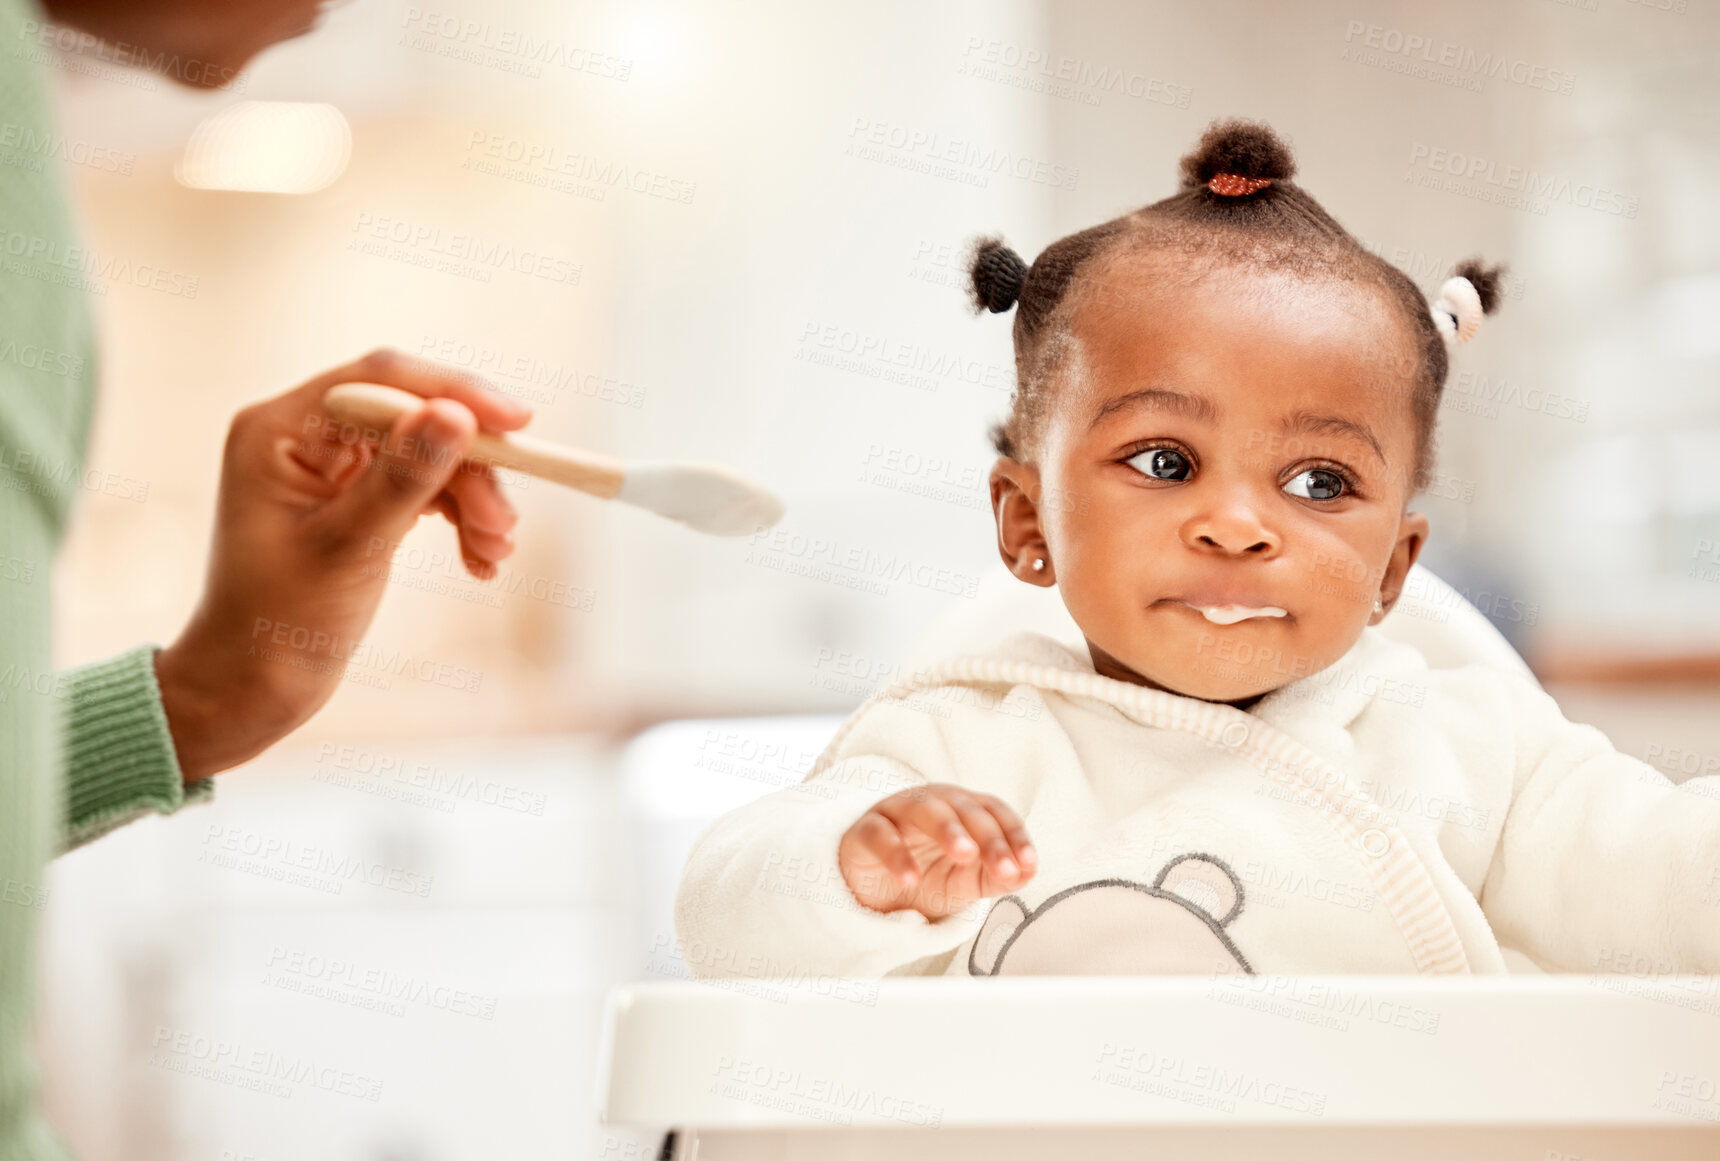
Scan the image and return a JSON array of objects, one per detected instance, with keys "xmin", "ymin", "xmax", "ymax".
[{"xmin": 836, "ymin": 783, "xmax": 1039, "ymax": 918}]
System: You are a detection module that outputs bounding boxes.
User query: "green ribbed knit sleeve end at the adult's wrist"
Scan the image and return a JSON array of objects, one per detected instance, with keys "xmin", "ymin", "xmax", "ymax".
[{"xmin": 62, "ymin": 645, "xmax": 215, "ymax": 850}]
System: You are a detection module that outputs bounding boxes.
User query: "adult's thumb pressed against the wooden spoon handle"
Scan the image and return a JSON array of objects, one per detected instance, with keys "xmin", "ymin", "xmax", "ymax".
[{"xmin": 327, "ymin": 399, "xmax": 478, "ymax": 544}]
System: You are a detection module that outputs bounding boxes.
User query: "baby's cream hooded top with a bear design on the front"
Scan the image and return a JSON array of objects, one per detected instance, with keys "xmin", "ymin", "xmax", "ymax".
[{"xmin": 676, "ymin": 630, "xmax": 1720, "ymax": 979}]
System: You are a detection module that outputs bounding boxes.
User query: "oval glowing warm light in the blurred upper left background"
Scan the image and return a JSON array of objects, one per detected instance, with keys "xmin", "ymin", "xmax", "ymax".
[{"xmin": 174, "ymin": 101, "xmax": 353, "ymax": 193}]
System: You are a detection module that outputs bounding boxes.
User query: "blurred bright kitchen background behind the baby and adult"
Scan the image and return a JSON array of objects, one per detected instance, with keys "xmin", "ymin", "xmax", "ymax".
[{"xmin": 26, "ymin": 0, "xmax": 1720, "ymax": 1161}]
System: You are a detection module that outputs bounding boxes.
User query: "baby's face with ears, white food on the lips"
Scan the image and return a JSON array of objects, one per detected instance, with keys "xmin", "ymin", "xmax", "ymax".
[{"xmin": 992, "ymin": 255, "xmax": 1428, "ymax": 702}]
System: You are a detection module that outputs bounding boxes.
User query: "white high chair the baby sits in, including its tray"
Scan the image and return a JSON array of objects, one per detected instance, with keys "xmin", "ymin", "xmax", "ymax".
[{"xmin": 599, "ymin": 566, "xmax": 1720, "ymax": 1161}]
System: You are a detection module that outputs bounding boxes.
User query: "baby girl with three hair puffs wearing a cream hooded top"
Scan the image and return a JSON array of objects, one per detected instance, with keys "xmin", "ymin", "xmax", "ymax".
[{"xmin": 676, "ymin": 122, "xmax": 1720, "ymax": 977}]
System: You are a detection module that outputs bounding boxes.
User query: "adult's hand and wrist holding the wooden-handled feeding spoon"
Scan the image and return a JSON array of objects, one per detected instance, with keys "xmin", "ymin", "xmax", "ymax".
[{"xmin": 155, "ymin": 351, "xmax": 531, "ymax": 783}]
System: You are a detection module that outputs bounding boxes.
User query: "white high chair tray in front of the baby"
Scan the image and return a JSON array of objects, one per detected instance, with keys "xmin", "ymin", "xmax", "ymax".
[{"xmin": 599, "ymin": 975, "xmax": 1720, "ymax": 1135}]
